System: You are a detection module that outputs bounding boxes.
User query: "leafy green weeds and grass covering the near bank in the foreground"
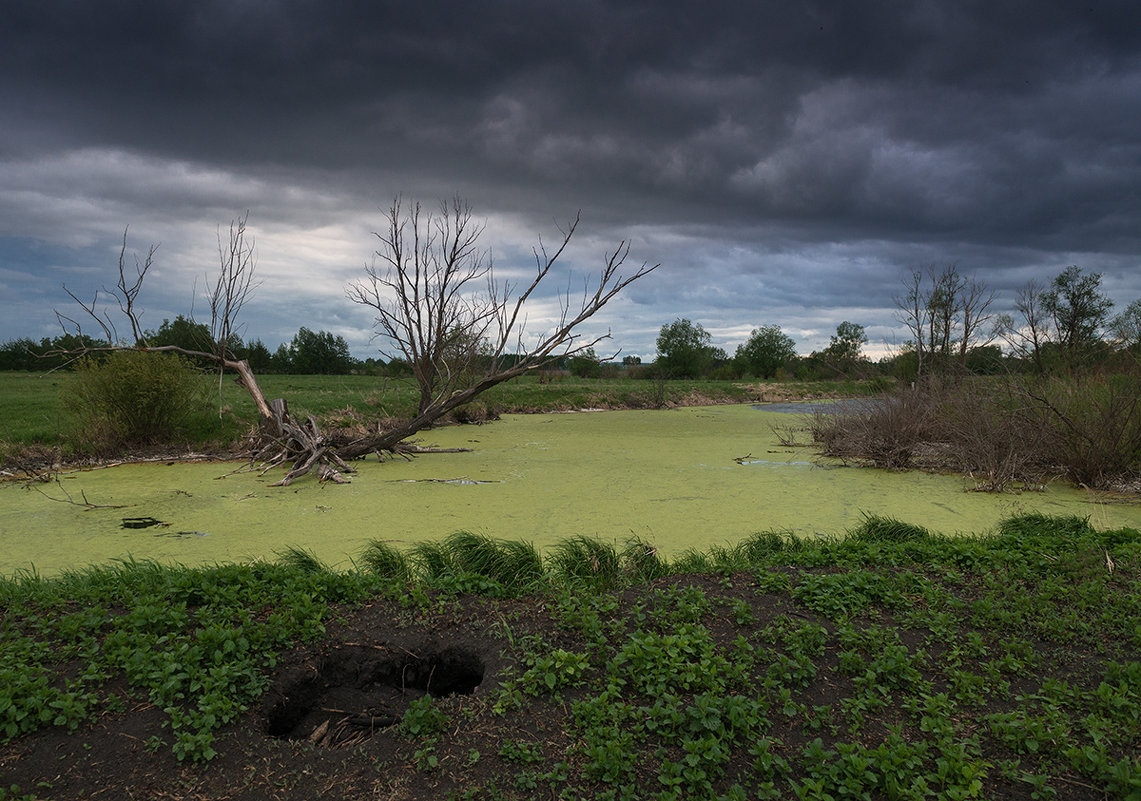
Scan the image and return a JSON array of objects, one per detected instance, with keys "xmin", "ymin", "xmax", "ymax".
[{"xmin": 0, "ymin": 516, "xmax": 1141, "ymax": 800}]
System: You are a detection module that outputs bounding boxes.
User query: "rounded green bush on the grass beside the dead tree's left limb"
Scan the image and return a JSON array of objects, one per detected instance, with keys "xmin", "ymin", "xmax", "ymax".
[{"xmin": 63, "ymin": 350, "xmax": 209, "ymax": 452}]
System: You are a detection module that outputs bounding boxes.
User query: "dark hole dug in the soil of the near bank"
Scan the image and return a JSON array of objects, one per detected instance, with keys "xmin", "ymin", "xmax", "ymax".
[{"xmin": 264, "ymin": 646, "xmax": 484, "ymax": 746}]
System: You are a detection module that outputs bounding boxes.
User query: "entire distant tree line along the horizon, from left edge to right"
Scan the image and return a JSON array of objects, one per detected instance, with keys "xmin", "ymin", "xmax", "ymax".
[{"xmin": 0, "ymin": 265, "xmax": 1141, "ymax": 381}]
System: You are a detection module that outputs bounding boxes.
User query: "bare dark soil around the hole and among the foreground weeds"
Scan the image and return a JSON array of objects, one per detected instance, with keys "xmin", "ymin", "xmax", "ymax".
[{"xmin": 0, "ymin": 574, "xmax": 1122, "ymax": 801}]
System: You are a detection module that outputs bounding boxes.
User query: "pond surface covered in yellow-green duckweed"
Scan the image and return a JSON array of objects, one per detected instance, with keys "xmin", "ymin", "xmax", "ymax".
[{"xmin": 0, "ymin": 405, "xmax": 1141, "ymax": 575}]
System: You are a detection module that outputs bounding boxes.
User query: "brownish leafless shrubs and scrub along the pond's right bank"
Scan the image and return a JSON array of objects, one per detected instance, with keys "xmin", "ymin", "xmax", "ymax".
[{"xmin": 810, "ymin": 371, "xmax": 1141, "ymax": 492}]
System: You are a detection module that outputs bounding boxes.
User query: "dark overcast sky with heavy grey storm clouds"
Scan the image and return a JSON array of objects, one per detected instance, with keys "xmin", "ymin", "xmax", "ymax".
[{"xmin": 0, "ymin": 0, "xmax": 1141, "ymax": 359}]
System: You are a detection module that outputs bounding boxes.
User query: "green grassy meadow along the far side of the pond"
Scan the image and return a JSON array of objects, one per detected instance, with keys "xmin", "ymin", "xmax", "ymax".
[{"xmin": 0, "ymin": 371, "xmax": 876, "ymax": 467}]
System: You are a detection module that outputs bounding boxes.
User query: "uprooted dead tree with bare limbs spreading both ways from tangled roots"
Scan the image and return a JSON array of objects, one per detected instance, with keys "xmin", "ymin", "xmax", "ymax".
[{"xmin": 56, "ymin": 200, "xmax": 657, "ymax": 486}]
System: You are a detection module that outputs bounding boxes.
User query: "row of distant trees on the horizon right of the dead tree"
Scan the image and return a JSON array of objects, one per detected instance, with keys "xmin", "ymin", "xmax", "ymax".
[{"xmin": 652, "ymin": 265, "xmax": 1141, "ymax": 381}]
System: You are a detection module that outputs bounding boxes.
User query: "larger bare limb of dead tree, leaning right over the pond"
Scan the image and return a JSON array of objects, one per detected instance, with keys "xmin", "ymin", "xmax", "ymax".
[{"xmin": 340, "ymin": 199, "xmax": 658, "ymax": 465}]
